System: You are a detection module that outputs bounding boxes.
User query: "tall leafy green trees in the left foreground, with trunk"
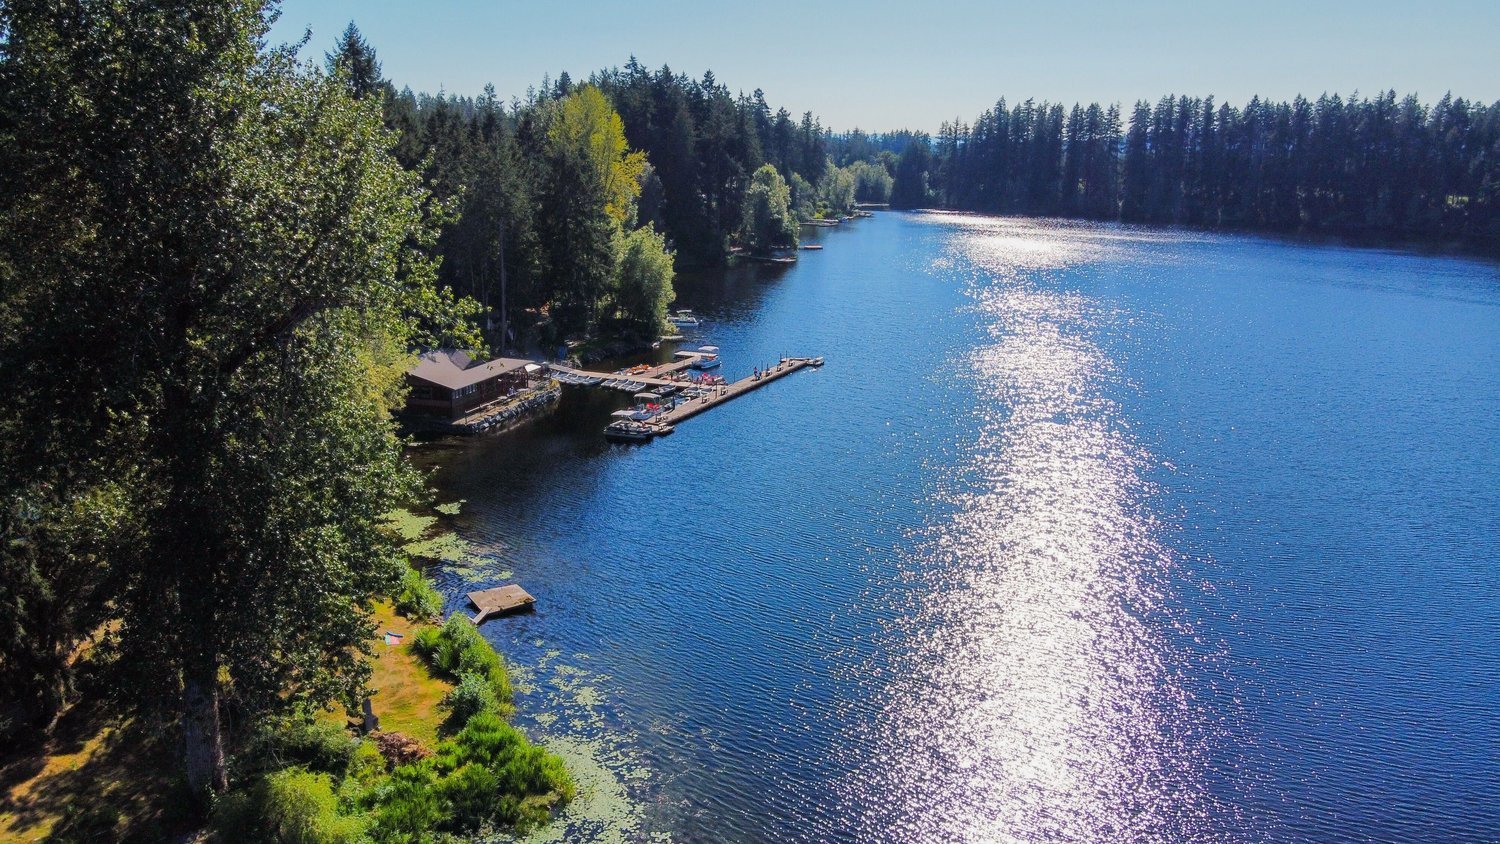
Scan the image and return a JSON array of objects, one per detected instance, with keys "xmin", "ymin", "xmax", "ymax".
[{"xmin": 0, "ymin": 0, "xmax": 474, "ymax": 795}]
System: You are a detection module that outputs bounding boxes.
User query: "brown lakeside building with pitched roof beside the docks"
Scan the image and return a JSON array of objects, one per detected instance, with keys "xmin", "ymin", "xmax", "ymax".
[{"xmin": 407, "ymin": 349, "xmax": 545, "ymax": 420}]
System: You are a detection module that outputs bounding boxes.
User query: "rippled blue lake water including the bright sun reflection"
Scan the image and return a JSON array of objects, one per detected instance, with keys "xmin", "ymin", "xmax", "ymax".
[{"xmin": 419, "ymin": 213, "xmax": 1500, "ymax": 841}]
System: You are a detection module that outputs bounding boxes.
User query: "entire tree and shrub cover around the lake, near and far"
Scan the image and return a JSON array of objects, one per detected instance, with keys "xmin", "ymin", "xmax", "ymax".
[{"xmin": 0, "ymin": 0, "xmax": 1500, "ymax": 841}]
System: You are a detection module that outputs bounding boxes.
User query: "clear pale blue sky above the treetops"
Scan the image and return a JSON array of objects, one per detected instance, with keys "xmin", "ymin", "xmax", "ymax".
[{"xmin": 272, "ymin": 0, "xmax": 1500, "ymax": 130}]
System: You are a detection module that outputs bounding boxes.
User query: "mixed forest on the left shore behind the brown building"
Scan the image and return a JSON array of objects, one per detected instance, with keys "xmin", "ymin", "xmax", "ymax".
[{"xmin": 375, "ymin": 47, "xmax": 893, "ymax": 348}]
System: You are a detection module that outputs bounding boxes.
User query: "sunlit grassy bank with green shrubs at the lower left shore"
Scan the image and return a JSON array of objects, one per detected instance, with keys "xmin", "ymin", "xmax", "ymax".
[{"xmin": 0, "ymin": 511, "xmax": 575, "ymax": 844}]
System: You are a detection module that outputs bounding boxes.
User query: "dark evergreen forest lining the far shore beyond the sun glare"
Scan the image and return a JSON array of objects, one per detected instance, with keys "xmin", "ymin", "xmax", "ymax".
[{"xmin": 876, "ymin": 91, "xmax": 1500, "ymax": 250}]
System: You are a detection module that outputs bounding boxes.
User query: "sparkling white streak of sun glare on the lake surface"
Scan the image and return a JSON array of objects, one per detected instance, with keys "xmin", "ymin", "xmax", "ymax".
[{"xmin": 857, "ymin": 217, "xmax": 1211, "ymax": 841}]
